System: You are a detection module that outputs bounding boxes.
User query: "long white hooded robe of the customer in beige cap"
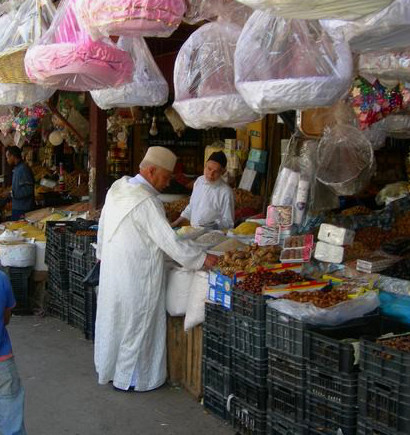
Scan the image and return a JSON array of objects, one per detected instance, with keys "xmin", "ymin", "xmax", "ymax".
[{"xmin": 94, "ymin": 177, "xmax": 205, "ymax": 391}]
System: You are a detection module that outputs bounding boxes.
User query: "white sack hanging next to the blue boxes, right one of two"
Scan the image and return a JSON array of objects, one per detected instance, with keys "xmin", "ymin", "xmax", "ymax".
[{"xmin": 184, "ymin": 271, "xmax": 209, "ymax": 331}]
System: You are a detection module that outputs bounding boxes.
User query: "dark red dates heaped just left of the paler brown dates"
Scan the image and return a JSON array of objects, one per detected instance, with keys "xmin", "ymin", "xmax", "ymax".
[{"xmin": 236, "ymin": 270, "xmax": 304, "ymax": 294}]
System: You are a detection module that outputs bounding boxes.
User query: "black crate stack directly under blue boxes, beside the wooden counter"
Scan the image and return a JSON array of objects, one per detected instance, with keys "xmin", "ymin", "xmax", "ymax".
[{"xmin": 202, "ymin": 302, "xmax": 232, "ymax": 420}]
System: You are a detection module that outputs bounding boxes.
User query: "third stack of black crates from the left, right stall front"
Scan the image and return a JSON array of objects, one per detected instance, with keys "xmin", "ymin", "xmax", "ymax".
[{"xmin": 266, "ymin": 307, "xmax": 308, "ymax": 435}]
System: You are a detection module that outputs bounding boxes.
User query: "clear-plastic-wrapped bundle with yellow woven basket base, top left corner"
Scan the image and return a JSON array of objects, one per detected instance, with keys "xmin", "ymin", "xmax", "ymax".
[{"xmin": 0, "ymin": 0, "xmax": 56, "ymax": 83}]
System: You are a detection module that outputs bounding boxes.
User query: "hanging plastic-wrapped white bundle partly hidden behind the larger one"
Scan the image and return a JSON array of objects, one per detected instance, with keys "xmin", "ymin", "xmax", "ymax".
[{"xmin": 173, "ymin": 22, "xmax": 259, "ymax": 129}]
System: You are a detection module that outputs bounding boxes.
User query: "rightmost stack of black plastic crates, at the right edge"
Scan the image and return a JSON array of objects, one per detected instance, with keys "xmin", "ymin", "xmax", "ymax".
[{"xmin": 357, "ymin": 333, "xmax": 410, "ymax": 435}]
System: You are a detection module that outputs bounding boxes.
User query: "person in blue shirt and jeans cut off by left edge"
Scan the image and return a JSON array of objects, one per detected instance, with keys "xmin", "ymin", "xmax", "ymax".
[{"xmin": 0, "ymin": 271, "xmax": 26, "ymax": 435}]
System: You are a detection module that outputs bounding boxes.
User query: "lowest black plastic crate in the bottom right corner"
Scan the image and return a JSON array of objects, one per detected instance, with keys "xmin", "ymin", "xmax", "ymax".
[{"xmin": 359, "ymin": 374, "xmax": 410, "ymax": 433}]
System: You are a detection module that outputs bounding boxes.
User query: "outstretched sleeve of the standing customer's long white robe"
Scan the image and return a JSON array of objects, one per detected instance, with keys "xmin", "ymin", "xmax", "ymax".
[{"xmin": 135, "ymin": 199, "xmax": 206, "ymax": 270}]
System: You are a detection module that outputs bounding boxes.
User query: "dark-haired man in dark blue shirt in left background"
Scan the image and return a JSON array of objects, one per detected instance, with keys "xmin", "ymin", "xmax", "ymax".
[{"xmin": 6, "ymin": 146, "xmax": 35, "ymax": 221}]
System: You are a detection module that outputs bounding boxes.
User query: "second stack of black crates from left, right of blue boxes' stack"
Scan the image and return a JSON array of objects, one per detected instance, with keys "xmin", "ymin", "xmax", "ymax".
[{"xmin": 229, "ymin": 289, "xmax": 268, "ymax": 435}]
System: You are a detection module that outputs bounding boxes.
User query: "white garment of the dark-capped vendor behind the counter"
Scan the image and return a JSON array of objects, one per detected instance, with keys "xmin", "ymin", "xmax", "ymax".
[{"xmin": 181, "ymin": 176, "xmax": 235, "ymax": 229}]
